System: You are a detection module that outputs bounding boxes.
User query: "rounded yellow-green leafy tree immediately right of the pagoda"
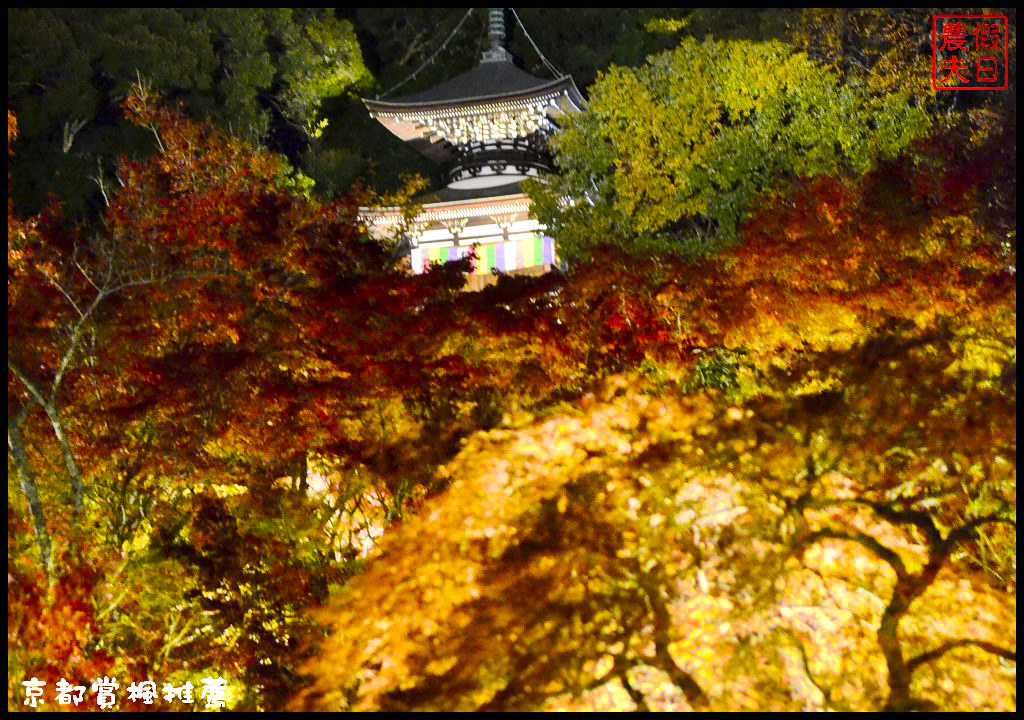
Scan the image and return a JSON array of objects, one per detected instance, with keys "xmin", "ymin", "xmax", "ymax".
[{"xmin": 531, "ymin": 39, "xmax": 928, "ymax": 258}]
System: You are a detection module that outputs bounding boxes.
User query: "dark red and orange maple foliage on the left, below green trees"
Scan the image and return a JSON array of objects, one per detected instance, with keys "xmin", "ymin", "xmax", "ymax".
[{"xmin": 8, "ymin": 87, "xmax": 481, "ymax": 706}]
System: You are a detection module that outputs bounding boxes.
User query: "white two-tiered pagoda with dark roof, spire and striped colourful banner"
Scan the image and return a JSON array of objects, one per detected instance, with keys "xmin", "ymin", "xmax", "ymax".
[{"xmin": 364, "ymin": 8, "xmax": 586, "ymax": 287}]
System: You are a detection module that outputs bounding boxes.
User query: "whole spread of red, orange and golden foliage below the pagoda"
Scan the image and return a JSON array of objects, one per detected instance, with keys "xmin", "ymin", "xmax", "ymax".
[{"xmin": 8, "ymin": 69, "xmax": 1016, "ymax": 711}]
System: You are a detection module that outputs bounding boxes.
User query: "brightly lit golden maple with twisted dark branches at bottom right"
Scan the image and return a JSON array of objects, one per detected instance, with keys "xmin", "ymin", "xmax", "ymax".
[{"xmin": 301, "ymin": 264, "xmax": 1016, "ymax": 711}]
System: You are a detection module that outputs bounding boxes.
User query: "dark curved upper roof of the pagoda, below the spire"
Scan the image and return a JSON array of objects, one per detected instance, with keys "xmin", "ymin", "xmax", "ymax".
[{"xmin": 364, "ymin": 61, "xmax": 586, "ymax": 113}]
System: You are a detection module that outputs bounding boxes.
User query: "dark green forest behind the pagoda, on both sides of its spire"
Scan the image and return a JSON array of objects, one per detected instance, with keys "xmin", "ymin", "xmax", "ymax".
[{"xmin": 7, "ymin": 8, "xmax": 787, "ymax": 214}]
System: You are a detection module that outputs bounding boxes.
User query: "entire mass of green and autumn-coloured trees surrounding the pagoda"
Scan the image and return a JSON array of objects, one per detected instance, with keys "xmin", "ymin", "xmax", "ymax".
[{"xmin": 8, "ymin": 8, "xmax": 1016, "ymax": 711}]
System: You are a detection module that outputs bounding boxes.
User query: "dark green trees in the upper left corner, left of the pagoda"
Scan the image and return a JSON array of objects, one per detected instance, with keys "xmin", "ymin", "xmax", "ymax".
[{"xmin": 7, "ymin": 8, "xmax": 369, "ymax": 213}]
